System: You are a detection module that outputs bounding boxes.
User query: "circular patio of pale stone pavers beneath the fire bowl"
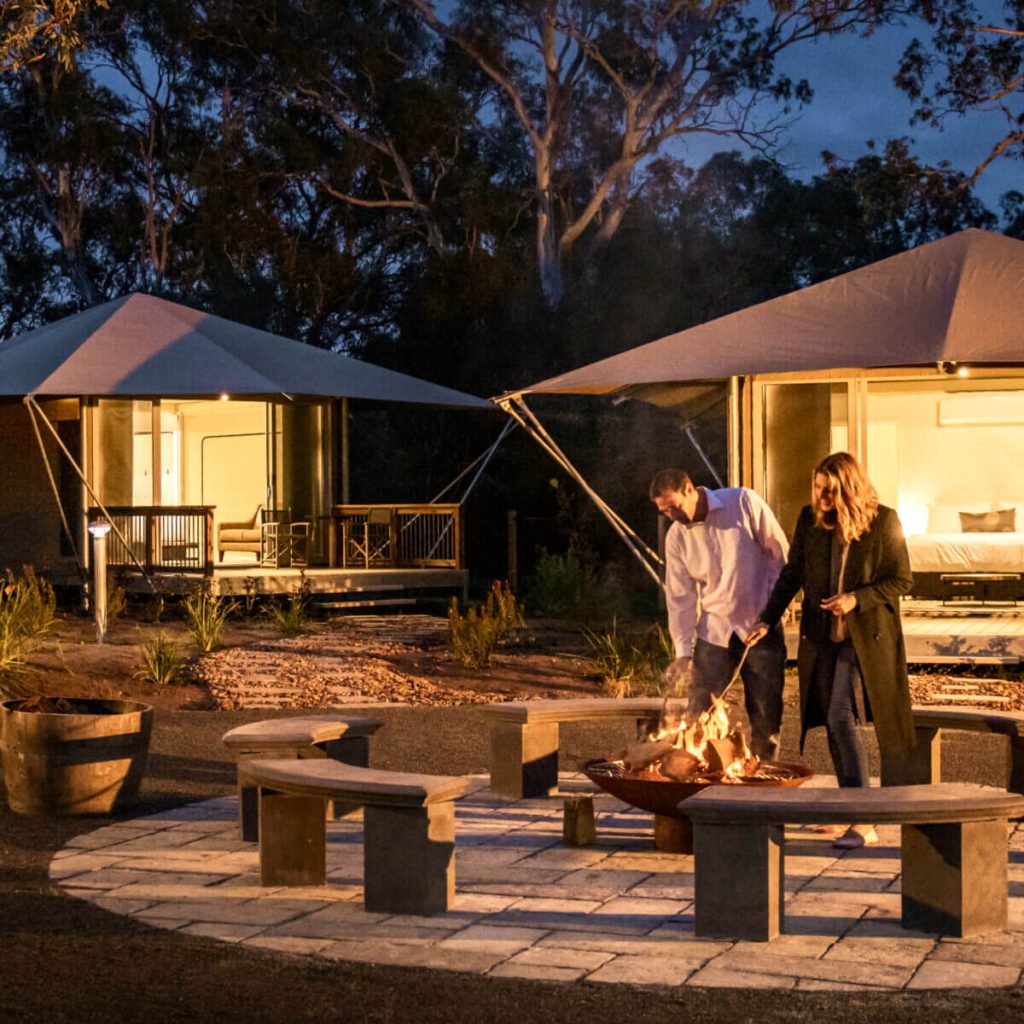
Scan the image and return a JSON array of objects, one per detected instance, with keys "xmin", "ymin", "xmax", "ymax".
[{"xmin": 50, "ymin": 775, "xmax": 1024, "ymax": 990}]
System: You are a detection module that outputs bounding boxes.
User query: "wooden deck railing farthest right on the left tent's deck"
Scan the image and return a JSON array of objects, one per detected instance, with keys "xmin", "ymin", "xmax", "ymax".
[{"xmin": 330, "ymin": 505, "xmax": 463, "ymax": 569}]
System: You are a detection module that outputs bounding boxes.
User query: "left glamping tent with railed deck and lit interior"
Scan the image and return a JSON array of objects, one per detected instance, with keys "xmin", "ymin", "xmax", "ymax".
[{"xmin": 0, "ymin": 294, "xmax": 493, "ymax": 589}]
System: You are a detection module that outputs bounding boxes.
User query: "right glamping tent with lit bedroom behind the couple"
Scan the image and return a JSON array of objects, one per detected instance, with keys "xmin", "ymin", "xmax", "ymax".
[{"xmin": 496, "ymin": 229, "xmax": 1024, "ymax": 597}]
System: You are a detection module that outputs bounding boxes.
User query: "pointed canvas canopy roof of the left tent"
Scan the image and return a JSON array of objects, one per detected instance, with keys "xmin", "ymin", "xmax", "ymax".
[{"xmin": 0, "ymin": 293, "xmax": 493, "ymax": 409}]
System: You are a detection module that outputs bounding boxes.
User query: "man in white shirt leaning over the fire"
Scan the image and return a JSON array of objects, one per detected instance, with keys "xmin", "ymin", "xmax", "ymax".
[{"xmin": 650, "ymin": 469, "xmax": 788, "ymax": 760}]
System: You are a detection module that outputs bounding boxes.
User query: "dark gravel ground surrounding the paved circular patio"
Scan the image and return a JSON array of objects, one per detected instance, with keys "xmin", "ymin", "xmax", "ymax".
[{"xmin": 0, "ymin": 708, "xmax": 1024, "ymax": 1024}]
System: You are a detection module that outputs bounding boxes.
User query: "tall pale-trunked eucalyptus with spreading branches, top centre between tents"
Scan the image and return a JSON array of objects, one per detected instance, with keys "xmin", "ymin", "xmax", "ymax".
[{"xmin": 394, "ymin": 0, "xmax": 909, "ymax": 307}]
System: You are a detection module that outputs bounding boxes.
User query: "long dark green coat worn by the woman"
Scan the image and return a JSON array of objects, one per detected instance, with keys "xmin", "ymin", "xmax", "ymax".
[{"xmin": 761, "ymin": 505, "xmax": 913, "ymax": 777}]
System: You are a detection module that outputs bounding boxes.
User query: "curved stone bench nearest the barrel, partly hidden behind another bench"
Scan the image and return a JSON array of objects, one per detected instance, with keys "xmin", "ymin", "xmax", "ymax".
[{"xmin": 221, "ymin": 715, "xmax": 384, "ymax": 843}]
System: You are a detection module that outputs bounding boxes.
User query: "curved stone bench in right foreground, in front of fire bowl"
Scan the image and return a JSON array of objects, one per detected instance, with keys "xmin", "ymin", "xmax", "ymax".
[{"xmin": 679, "ymin": 782, "xmax": 1024, "ymax": 942}]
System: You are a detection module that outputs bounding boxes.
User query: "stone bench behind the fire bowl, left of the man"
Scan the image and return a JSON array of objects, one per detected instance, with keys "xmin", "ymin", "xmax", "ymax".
[{"xmin": 480, "ymin": 697, "xmax": 685, "ymax": 800}]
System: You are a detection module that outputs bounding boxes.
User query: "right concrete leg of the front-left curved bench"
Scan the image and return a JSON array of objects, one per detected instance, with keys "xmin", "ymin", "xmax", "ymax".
[{"xmin": 362, "ymin": 801, "xmax": 455, "ymax": 914}]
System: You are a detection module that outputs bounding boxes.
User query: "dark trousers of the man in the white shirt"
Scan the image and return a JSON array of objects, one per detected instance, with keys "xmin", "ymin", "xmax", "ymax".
[{"xmin": 687, "ymin": 626, "xmax": 785, "ymax": 761}]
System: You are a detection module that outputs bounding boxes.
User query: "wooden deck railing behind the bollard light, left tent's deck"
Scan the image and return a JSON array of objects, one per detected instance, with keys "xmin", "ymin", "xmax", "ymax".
[{"xmin": 89, "ymin": 505, "xmax": 213, "ymax": 572}]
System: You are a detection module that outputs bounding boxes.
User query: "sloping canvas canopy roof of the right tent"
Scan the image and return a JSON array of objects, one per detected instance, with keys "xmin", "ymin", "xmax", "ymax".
[{"xmin": 513, "ymin": 228, "xmax": 1024, "ymax": 397}]
